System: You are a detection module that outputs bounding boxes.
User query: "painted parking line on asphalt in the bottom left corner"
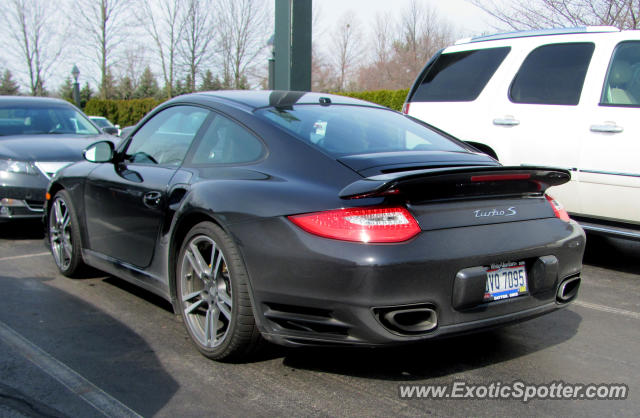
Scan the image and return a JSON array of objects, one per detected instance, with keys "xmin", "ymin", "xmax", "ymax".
[{"xmin": 0, "ymin": 321, "xmax": 141, "ymax": 417}]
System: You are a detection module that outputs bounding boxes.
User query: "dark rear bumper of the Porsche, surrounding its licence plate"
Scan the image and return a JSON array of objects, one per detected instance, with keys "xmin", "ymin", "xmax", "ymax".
[{"xmin": 232, "ymin": 218, "xmax": 585, "ymax": 345}]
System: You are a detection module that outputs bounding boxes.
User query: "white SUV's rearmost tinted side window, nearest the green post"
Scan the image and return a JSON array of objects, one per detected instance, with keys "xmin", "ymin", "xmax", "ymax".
[{"xmin": 411, "ymin": 47, "xmax": 511, "ymax": 102}]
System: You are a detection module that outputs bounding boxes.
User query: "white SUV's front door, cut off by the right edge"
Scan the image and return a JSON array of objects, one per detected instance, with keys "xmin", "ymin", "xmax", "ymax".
[{"xmin": 578, "ymin": 36, "xmax": 640, "ymax": 224}]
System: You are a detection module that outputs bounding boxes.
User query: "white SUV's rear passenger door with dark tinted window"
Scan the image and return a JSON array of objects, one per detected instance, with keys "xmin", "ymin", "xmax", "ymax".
[{"xmin": 491, "ymin": 39, "xmax": 595, "ymax": 212}]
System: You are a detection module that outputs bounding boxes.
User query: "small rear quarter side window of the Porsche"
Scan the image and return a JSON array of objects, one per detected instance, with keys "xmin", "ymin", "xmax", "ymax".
[{"xmin": 189, "ymin": 115, "xmax": 265, "ymax": 164}]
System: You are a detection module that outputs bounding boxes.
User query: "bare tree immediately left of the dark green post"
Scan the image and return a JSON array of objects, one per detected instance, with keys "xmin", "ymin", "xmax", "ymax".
[{"xmin": 216, "ymin": 0, "xmax": 271, "ymax": 88}]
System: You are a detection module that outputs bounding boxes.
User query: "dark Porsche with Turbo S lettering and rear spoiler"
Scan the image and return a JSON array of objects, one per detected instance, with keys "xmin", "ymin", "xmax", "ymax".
[{"xmin": 45, "ymin": 91, "xmax": 585, "ymax": 359}]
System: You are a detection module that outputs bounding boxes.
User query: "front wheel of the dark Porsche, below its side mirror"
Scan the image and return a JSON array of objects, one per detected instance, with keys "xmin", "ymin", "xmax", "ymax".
[{"xmin": 48, "ymin": 190, "xmax": 85, "ymax": 277}]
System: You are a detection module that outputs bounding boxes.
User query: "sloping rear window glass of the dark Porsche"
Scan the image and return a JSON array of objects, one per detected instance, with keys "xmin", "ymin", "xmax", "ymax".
[{"xmin": 256, "ymin": 105, "xmax": 466, "ymax": 156}]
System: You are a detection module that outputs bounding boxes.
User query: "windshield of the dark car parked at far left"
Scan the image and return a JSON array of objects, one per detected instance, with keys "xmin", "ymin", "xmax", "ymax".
[{"xmin": 0, "ymin": 104, "xmax": 99, "ymax": 136}]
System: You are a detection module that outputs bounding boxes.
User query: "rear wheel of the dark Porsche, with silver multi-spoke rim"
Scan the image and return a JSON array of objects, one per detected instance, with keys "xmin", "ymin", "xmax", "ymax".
[{"xmin": 175, "ymin": 222, "xmax": 262, "ymax": 361}]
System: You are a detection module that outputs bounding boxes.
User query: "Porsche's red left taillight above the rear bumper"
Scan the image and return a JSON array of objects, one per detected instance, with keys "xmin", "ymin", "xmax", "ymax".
[{"xmin": 289, "ymin": 207, "xmax": 420, "ymax": 243}]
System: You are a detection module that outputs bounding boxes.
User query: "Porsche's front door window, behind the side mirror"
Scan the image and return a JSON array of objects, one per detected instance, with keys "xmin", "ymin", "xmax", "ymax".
[{"xmin": 127, "ymin": 106, "xmax": 210, "ymax": 166}]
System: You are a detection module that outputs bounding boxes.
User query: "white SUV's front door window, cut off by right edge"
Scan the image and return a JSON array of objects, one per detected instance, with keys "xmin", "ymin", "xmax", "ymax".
[{"xmin": 600, "ymin": 41, "xmax": 640, "ymax": 106}]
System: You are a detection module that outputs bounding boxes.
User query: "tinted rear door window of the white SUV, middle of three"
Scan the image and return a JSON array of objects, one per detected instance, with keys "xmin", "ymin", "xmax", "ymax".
[{"xmin": 509, "ymin": 42, "xmax": 594, "ymax": 105}]
